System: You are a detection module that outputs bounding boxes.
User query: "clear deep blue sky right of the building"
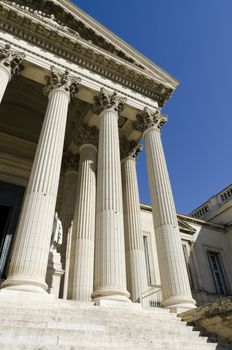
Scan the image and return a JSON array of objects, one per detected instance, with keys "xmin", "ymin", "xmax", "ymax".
[{"xmin": 75, "ymin": 0, "xmax": 232, "ymax": 214}]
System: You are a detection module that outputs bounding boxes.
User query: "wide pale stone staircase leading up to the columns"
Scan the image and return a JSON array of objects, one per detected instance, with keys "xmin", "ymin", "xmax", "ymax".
[{"xmin": 0, "ymin": 293, "xmax": 232, "ymax": 350}]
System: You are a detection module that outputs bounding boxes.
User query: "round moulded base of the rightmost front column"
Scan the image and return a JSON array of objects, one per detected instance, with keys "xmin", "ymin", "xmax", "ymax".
[{"xmin": 161, "ymin": 296, "xmax": 196, "ymax": 314}]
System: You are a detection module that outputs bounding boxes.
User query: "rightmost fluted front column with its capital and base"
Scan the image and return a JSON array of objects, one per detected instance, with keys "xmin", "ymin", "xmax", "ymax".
[{"xmin": 135, "ymin": 108, "xmax": 195, "ymax": 310}]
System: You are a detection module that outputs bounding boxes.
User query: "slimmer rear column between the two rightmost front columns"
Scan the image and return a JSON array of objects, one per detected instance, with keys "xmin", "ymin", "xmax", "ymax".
[{"xmin": 121, "ymin": 142, "xmax": 147, "ymax": 302}]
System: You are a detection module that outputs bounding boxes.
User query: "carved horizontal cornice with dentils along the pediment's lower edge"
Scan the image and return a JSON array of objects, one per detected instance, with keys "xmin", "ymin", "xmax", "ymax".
[{"xmin": 0, "ymin": 1, "xmax": 173, "ymax": 107}]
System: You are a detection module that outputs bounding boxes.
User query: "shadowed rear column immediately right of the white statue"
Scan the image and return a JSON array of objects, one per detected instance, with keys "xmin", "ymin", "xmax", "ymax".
[{"xmin": 59, "ymin": 152, "xmax": 79, "ymax": 299}]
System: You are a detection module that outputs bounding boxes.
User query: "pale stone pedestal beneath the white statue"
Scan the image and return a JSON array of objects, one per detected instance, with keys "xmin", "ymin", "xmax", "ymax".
[{"xmin": 46, "ymin": 251, "xmax": 64, "ymax": 298}]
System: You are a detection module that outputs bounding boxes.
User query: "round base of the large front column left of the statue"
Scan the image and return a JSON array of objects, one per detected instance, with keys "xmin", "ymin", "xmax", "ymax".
[{"xmin": 1, "ymin": 278, "xmax": 48, "ymax": 295}]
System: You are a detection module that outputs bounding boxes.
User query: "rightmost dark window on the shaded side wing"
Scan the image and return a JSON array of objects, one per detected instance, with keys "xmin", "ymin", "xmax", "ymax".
[{"xmin": 208, "ymin": 251, "xmax": 228, "ymax": 295}]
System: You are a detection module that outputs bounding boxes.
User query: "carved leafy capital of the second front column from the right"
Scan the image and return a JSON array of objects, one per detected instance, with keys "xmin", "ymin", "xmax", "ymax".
[{"xmin": 93, "ymin": 88, "xmax": 126, "ymax": 114}]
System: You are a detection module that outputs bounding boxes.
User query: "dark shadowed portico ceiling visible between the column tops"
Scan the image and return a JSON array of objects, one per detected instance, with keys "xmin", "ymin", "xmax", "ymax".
[{"xmin": 0, "ymin": 76, "xmax": 141, "ymax": 157}]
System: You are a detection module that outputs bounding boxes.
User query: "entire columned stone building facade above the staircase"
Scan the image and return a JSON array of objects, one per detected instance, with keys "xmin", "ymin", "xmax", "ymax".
[{"xmin": 0, "ymin": 0, "xmax": 232, "ymax": 310}]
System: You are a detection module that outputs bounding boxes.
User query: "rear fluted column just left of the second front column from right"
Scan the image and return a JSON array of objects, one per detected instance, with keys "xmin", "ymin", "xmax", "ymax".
[{"xmin": 68, "ymin": 125, "xmax": 98, "ymax": 301}]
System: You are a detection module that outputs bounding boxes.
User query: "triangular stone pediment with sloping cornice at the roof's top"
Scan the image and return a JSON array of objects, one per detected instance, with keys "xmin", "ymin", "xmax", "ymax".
[{"xmin": 2, "ymin": 0, "xmax": 178, "ymax": 106}]
